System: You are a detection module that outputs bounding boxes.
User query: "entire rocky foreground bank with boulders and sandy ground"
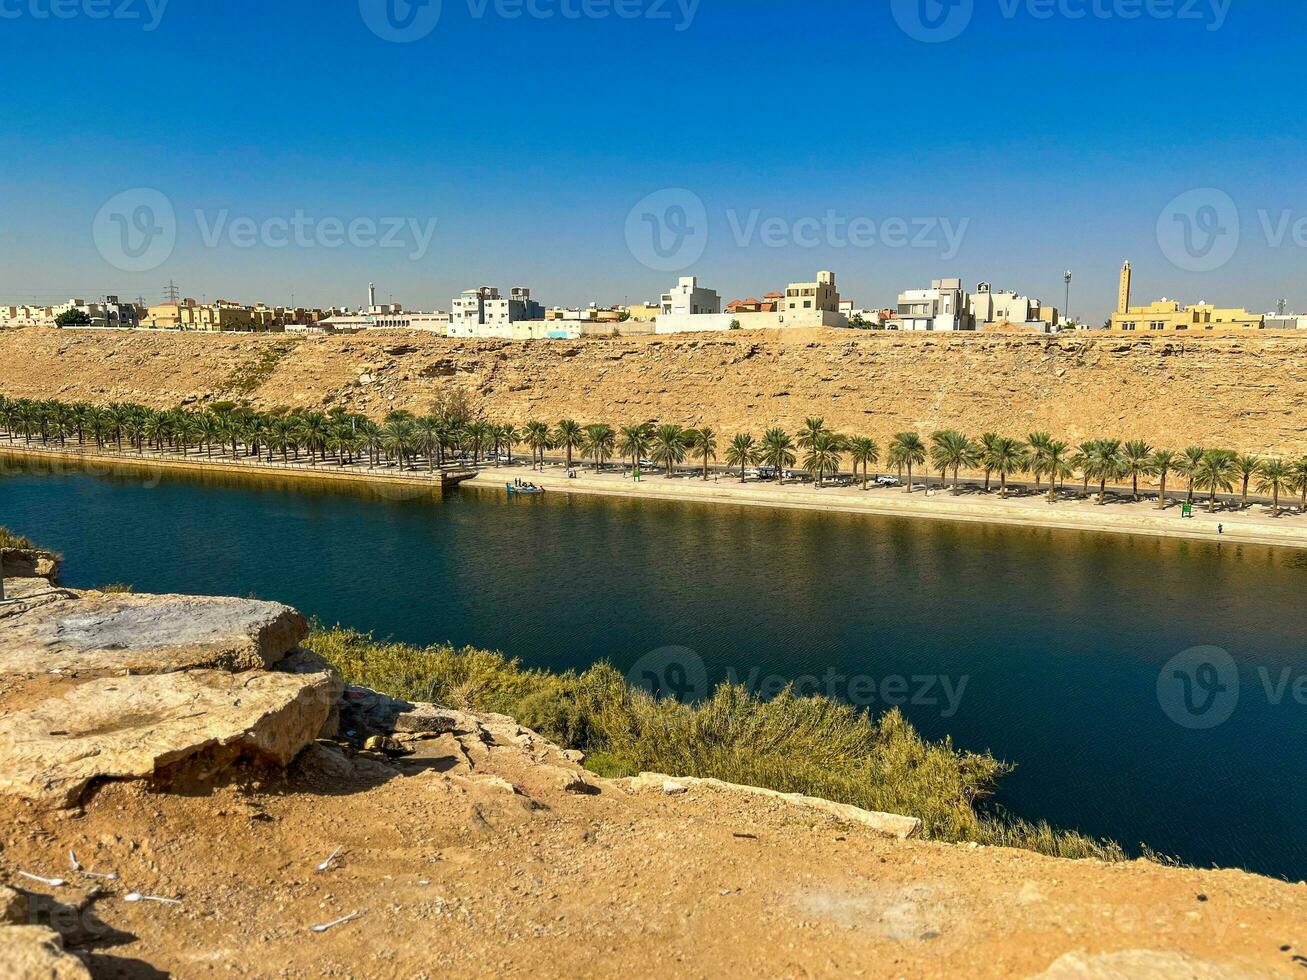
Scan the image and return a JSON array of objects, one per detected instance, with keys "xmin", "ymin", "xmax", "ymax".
[{"xmin": 0, "ymin": 579, "xmax": 1307, "ymax": 979}]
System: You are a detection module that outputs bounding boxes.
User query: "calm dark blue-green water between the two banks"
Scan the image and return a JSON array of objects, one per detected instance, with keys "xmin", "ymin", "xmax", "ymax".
[{"xmin": 0, "ymin": 461, "xmax": 1307, "ymax": 879}]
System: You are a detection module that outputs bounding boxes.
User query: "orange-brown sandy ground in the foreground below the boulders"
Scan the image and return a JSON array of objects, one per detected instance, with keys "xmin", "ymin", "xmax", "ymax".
[{"xmin": 0, "ymin": 736, "xmax": 1307, "ymax": 977}]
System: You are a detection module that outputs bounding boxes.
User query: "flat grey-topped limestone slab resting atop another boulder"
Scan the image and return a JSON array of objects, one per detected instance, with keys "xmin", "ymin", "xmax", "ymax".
[{"xmin": 0, "ymin": 588, "xmax": 308, "ymax": 674}]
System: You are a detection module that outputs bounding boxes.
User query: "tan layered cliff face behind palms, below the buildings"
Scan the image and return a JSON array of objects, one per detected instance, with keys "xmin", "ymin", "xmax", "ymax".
[{"xmin": 0, "ymin": 329, "xmax": 1307, "ymax": 455}]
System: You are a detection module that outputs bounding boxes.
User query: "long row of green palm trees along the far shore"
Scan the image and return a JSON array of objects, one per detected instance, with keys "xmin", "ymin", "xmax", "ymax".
[{"xmin": 0, "ymin": 396, "xmax": 1307, "ymax": 516}]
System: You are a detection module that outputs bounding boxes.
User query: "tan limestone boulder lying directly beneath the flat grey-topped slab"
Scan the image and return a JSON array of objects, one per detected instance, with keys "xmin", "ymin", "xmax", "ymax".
[{"xmin": 0, "ymin": 670, "xmax": 341, "ymax": 808}]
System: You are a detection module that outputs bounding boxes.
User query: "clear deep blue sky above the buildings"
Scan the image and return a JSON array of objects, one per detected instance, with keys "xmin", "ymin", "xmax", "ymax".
[{"xmin": 0, "ymin": 0, "xmax": 1307, "ymax": 320}]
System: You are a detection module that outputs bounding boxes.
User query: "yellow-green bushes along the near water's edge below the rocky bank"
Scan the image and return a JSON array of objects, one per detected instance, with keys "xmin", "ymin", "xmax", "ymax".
[{"xmin": 310, "ymin": 627, "xmax": 1127, "ymax": 860}]
